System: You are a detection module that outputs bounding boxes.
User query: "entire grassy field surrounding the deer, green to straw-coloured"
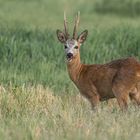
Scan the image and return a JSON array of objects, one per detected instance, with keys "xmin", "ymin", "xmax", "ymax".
[{"xmin": 0, "ymin": 0, "xmax": 140, "ymax": 140}]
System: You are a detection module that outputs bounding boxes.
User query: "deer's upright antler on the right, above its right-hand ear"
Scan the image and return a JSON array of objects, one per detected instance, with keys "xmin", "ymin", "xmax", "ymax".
[{"xmin": 73, "ymin": 11, "xmax": 80, "ymax": 39}]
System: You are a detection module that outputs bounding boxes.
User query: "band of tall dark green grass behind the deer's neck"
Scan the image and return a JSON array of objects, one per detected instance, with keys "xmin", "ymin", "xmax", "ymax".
[{"xmin": 0, "ymin": 25, "xmax": 140, "ymax": 93}]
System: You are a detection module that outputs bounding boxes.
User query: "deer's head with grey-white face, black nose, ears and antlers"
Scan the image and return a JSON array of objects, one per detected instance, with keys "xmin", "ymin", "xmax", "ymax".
[{"xmin": 56, "ymin": 12, "xmax": 88, "ymax": 62}]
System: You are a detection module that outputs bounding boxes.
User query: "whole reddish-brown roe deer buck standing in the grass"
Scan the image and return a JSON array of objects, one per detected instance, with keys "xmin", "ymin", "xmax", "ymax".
[{"xmin": 56, "ymin": 14, "xmax": 140, "ymax": 109}]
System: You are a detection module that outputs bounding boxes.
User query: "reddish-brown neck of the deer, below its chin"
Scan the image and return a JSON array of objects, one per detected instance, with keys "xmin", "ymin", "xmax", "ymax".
[{"xmin": 67, "ymin": 53, "xmax": 82, "ymax": 84}]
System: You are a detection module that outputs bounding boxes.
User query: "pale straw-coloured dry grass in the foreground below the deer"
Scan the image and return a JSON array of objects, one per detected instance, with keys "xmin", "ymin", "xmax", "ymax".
[{"xmin": 0, "ymin": 85, "xmax": 140, "ymax": 140}]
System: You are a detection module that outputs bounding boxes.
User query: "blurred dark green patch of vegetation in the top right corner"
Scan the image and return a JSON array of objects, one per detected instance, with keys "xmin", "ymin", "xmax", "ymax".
[{"xmin": 95, "ymin": 0, "xmax": 140, "ymax": 17}]
